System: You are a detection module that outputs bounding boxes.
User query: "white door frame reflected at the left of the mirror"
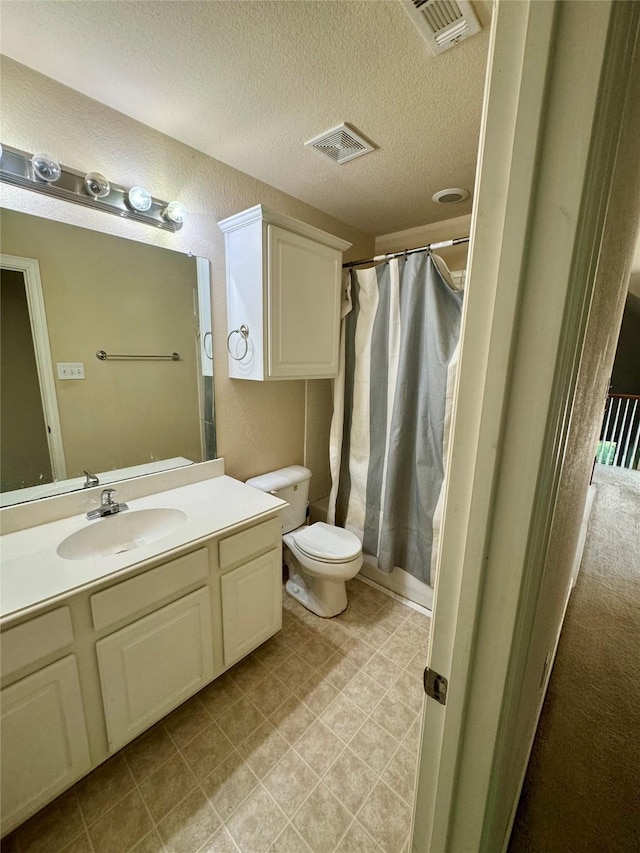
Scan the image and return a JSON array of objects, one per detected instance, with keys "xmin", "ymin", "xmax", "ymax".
[{"xmin": 0, "ymin": 254, "xmax": 67, "ymax": 481}]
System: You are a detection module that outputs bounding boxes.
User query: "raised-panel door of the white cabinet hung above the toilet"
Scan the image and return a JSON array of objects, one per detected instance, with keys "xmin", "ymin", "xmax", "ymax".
[{"xmin": 267, "ymin": 225, "xmax": 342, "ymax": 379}]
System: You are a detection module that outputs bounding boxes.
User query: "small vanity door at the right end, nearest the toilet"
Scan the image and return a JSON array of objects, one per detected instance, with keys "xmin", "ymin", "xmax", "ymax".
[{"xmin": 221, "ymin": 548, "xmax": 282, "ymax": 666}]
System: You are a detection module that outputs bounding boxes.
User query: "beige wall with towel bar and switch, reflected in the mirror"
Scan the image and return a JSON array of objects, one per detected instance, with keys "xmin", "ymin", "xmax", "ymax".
[{"xmin": 0, "ymin": 210, "xmax": 201, "ymax": 477}]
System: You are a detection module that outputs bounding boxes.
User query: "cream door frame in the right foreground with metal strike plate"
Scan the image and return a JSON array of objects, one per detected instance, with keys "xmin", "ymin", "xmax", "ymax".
[{"xmin": 413, "ymin": 0, "xmax": 640, "ymax": 853}]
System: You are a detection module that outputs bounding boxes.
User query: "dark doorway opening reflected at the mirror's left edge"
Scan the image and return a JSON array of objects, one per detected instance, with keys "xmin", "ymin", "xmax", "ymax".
[{"xmin": 0, "ymin": 270, "xmax": 53, "ymax": 491}]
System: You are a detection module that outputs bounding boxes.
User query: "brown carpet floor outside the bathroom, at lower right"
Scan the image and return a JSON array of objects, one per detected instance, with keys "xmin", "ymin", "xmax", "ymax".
[{"xmin": 509, "ymin": 465, "xmax": 640, "ymax": 853}]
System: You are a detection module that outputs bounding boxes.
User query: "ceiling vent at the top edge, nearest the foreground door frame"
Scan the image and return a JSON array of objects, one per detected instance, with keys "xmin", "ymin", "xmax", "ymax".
[{"xmin": 401, "ymin": 0, "xmax": 482, "ymax": 54}]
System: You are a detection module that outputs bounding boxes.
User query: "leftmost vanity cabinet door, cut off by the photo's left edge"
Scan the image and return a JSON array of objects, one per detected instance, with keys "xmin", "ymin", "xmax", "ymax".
[{"xmin": 1, "ymin": 655, "xmax": 90, "ymax": 832}]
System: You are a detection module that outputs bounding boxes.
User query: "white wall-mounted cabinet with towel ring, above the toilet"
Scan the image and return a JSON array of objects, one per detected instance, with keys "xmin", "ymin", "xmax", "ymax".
[{"xmin": 218, "ymin": 204, "xmax": 351, "ymax": 380}]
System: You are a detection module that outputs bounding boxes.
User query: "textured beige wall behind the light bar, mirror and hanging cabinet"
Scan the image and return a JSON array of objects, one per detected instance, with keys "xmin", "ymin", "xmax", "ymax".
[{"xmin": 0, "ymin": 58, "xmax": 373, "ymax": 486}]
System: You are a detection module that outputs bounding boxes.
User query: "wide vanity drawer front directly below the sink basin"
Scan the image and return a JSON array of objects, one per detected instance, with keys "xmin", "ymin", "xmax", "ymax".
[{"xmin": 91, "ymin": 548, "xmax": 209, "ymax": 630}]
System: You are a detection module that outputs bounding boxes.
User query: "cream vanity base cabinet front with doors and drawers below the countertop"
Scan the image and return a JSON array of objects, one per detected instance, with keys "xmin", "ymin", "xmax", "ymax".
[{"xmin": 0, "ymin": 514, "xmax": 282, "ymax": 834}]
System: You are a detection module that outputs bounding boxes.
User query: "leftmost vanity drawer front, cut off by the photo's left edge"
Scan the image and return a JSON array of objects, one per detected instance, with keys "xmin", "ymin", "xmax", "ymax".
[{"xmin": 2, "ymin": 607, "xmax": 73, "ymax": 678}]
